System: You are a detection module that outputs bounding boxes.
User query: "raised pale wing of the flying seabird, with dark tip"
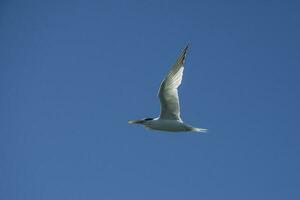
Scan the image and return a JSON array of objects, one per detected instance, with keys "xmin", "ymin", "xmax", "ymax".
[{"xmin": 158, "ymin": 46, "xmax": 188, "ymax": 120}]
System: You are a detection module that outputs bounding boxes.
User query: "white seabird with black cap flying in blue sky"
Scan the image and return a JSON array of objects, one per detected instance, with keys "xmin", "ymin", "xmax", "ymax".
[{"xmin": 128, "ymin": 45, "xmax": 207, "ymax": 133}]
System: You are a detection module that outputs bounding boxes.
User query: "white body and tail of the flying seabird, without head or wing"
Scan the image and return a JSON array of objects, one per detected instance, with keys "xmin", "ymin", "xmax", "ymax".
[{"xmin": 143, "ymin": 118, "xmax": 206, "ymax": 132}]
